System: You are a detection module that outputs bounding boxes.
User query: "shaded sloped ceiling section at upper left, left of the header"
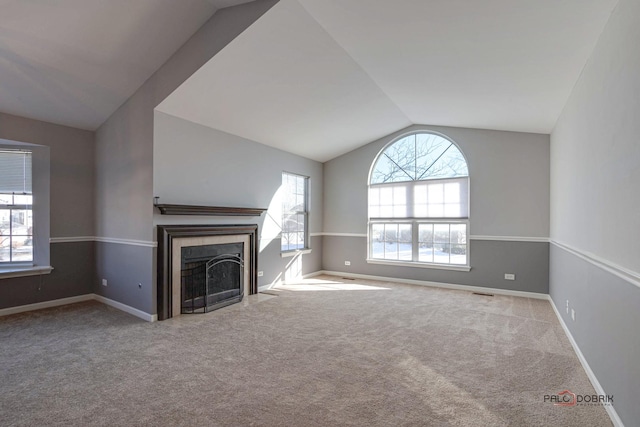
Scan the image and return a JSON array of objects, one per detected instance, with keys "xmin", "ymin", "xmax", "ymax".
[{"xmin": 0, "ymin": 0, "xmax": 255, "ymax": 130}]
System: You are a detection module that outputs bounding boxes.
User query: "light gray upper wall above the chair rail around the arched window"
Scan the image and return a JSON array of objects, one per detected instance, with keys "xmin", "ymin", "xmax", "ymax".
[{"xmin": 324, "ymin": 126, "xmax": 549, "ymax": 237}]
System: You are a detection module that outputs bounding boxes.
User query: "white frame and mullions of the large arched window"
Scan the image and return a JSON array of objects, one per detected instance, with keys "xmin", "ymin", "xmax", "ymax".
[{"xmin": 366, "ymin": 130, "xmax": 471, "ymax": 271}]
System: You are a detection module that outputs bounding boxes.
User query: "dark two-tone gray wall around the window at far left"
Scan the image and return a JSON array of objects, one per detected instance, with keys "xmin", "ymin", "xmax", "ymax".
[{"xmin": 0, "ymin": 113, "xmax": 95, "ymax": 309}]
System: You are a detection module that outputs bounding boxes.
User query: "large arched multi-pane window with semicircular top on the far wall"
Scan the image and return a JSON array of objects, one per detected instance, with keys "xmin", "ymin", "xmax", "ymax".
[{"xmin": 369, "ymin": 132, "xmax": 469, "ymax": 266}]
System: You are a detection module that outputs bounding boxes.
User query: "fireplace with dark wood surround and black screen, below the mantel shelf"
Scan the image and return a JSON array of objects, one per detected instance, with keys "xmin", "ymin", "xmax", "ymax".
[{"xmin": 158, "ymin": 224, "xmax": 258, "ymax": 320}]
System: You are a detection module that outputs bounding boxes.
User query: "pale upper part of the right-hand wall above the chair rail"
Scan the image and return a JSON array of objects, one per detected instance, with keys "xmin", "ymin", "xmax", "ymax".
[{"xmin": 551, "ymin": 0, "xmax": 640, "ymax": 272}]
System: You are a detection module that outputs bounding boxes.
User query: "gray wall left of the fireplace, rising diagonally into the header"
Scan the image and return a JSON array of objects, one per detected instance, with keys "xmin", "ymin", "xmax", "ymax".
[{"xmin": 93, "ymin": 0, "xmax": 277, "ymax": 313}]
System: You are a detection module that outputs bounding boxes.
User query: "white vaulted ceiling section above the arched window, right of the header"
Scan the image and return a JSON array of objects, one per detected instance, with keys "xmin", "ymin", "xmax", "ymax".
[{"xmin": 158, "ymin": 0, "xmax": 617, "ymax": 161}]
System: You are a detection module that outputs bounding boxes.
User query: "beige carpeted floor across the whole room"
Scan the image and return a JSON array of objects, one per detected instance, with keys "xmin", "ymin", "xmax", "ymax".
[{"xmin": 0, "ymin": 276, "xmax": 611, "ymax": 427}]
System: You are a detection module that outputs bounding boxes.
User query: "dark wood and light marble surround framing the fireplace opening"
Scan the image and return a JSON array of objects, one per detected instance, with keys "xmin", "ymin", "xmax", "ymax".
[{"xmin": 157, "ymin": 224, "xmax": 258, "ymax": 320}]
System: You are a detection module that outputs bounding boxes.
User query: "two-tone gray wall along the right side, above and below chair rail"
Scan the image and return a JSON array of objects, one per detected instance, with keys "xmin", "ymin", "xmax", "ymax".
[{"xmin": 550, "ymin": 0, "xmax": 640, "ymax": 426}]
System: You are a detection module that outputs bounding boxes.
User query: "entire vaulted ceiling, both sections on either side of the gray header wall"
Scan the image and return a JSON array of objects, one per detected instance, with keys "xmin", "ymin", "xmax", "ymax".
[{"xmin": 0, "ymin": 0, "xmax": 617, "ymax": 161}]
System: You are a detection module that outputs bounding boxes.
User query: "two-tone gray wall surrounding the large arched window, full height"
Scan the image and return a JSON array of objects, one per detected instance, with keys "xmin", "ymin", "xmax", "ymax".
[{"xmin": 322, "ymin": 126, "xmax": 549, "ymax": 293}]
